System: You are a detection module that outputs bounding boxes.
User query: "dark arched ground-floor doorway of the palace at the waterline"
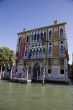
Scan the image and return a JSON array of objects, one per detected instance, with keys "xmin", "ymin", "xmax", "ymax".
[{"xmin": 33, "ymin": 63, "xmax": 40, "ymax": 80}]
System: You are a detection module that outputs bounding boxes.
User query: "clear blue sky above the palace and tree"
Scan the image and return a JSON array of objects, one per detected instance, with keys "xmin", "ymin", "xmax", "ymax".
[{"xmin": 0, "ymin": 0, "xmax": 73, "ymax": 63}]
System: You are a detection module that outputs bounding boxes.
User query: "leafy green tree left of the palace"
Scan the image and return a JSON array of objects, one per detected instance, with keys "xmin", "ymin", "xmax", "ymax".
[{"xmin": 0, "ymin": 47, "xmax": 15, "ymax": 68}]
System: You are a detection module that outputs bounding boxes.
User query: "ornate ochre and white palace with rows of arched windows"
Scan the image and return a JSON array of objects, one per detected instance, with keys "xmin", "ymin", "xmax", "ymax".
[{"xmin": 16, "ymin": 21, "xmax": 68, "ymax": 81}]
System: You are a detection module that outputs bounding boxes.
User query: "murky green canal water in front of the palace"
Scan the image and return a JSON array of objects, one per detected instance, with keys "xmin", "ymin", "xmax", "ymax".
[{"xmin": 0, "ymin": 80, "xmax": 73, "ymax": 110}]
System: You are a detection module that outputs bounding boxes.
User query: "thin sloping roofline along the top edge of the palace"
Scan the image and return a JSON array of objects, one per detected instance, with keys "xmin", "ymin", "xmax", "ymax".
[{"xmin": 17, "ymin": 22, "xmax": 66, "ymax": 35}]
